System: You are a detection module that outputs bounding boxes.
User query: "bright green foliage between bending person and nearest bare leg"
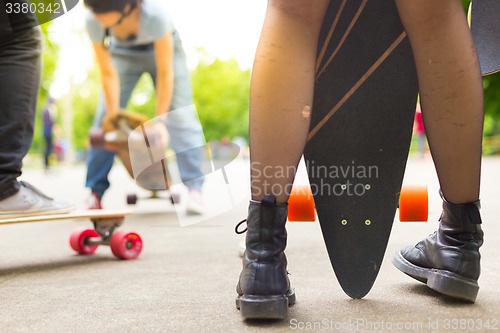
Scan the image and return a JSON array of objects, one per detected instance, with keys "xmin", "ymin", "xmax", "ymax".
[{"xmin": 192, "ymin": 53, "xmax": 250, "ymax": 142}]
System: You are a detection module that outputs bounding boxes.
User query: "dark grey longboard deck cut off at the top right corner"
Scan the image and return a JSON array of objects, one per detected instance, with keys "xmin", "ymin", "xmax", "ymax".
[{"xmin": 469, "ymin": 0, "xmax": 500, "ymax": 75}]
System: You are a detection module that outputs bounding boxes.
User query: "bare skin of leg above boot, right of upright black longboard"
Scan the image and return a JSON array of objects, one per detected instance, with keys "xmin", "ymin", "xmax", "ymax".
[{"xmin": 396, "ymin": 0, "xmax": 483, "ymax": 204}]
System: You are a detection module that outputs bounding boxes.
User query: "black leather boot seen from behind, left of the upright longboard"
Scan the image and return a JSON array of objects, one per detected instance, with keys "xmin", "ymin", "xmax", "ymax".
[{"xmin": 236, "ymin": 196, "xmax": 295, "ymax": 319}]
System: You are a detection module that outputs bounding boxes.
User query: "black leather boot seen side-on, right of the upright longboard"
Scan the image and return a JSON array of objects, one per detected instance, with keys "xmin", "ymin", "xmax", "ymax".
[{"xmin": 392, "ymin": 189, "xmax": 483, "ymax": 302}]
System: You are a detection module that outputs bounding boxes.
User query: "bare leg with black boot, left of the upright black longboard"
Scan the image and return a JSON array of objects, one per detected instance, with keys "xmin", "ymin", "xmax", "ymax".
[{"xmin": 236, "ymin": 0, "xmax": 330, "ymax": 319}]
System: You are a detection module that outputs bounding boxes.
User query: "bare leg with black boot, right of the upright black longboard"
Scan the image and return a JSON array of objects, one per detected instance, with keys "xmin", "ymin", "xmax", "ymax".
[{"xmin": 393, "ymin": 0, "xmax": 483, "ymax": 301}]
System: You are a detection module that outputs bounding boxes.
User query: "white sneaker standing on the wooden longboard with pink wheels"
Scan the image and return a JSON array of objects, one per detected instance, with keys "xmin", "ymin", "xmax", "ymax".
[{"xmin": 0, "ymin": 181, "xmax": 76, "ymax": 219}]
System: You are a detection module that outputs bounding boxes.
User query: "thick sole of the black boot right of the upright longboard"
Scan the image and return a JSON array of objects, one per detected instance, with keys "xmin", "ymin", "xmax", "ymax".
[{"xmin": 392, "ymin": 252, "xmax": 479, "ymax": 303}]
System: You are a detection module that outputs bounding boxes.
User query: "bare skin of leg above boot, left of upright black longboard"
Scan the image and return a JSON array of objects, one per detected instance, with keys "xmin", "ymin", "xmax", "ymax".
[{"xmin": 250, "ymin": 0, "xmax": 330, "ymax": 203}]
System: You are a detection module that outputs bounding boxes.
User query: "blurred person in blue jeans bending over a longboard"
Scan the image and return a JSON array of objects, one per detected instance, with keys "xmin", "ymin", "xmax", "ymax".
[{"xmin": 85, "ymin": 0, "xmax": 205, "ymax": 214}]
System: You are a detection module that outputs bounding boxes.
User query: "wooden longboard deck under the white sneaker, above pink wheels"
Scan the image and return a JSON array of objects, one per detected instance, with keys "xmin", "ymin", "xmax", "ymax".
[{"xmin": 0, "ymin": 209, "xmax": 133, "ymax": 225}]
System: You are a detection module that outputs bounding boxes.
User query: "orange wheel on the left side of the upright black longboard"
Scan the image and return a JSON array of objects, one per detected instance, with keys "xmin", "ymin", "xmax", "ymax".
[{"xmin": 288, "ymin": 185, "xmax": 316, "ymax": 222}]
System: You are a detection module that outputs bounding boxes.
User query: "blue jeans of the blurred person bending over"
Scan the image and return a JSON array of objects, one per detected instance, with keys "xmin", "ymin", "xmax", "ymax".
[{"xmin": 86, "ymin": 48, "xmax": 205, "ymax": 197}]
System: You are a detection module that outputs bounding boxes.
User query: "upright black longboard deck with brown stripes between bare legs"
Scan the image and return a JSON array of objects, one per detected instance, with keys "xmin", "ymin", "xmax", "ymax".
[{"xmin": 305, "ymin": 0, "xmax": 418, "ymax": 298}]
